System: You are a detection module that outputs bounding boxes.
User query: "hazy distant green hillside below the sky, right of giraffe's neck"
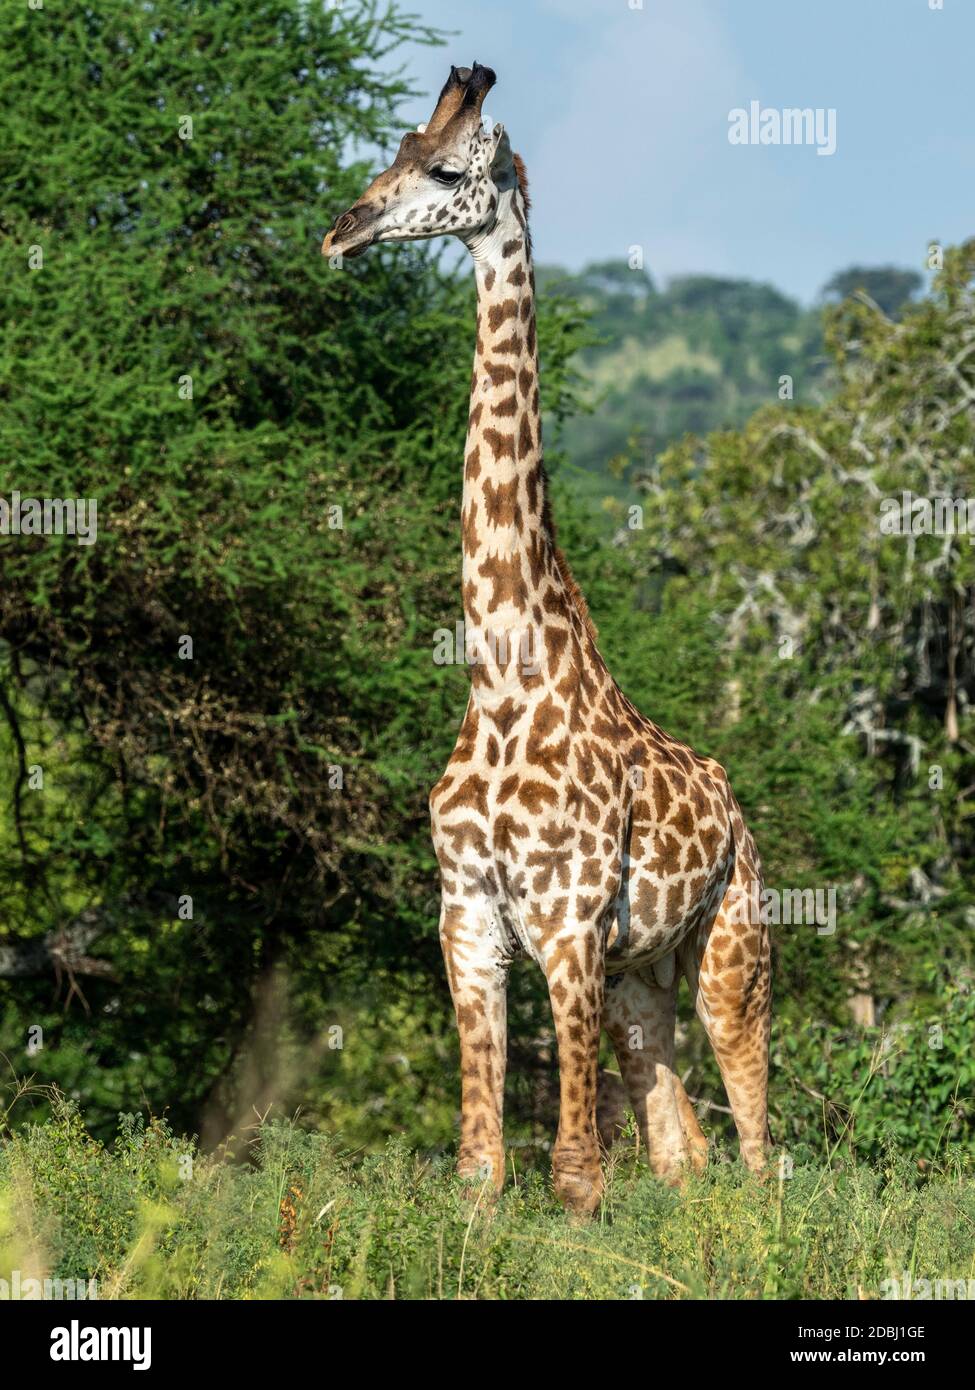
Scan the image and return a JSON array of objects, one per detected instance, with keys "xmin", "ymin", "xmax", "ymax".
[{"xmin": 538, "ymin": 261, "xmax": 922, "ymax": 503}]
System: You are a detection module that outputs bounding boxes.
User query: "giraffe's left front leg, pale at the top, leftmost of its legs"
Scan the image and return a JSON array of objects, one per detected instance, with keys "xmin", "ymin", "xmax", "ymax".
[{"xmin": 440, "ymin": 905, "xmax": 509, "ymax": 1191}]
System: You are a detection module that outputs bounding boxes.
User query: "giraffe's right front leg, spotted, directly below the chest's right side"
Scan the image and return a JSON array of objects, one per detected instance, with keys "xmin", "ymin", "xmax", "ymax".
[{"xmin": 540, "ymin": 923, "xmax": 605, "ymax": 1216}]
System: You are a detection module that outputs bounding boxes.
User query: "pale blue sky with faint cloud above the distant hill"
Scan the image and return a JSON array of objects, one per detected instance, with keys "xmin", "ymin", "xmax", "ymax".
[{"xmin": 383, "ymin": 0, "xmax": 975, "ymax": 302}]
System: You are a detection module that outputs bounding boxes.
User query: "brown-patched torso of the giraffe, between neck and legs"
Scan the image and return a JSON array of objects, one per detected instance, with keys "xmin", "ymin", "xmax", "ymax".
[{"xmin": 430, "ymin": 701, "xmax": 732, "ymax": 973}]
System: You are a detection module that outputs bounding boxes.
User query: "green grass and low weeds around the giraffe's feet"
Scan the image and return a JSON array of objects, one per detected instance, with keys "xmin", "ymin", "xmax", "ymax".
[{"xmin": 0, "ymin": 1095, "xmax": 975, "ymax": 1300}]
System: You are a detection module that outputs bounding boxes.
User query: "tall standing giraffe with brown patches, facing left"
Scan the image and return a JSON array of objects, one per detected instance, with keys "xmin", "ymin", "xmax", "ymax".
[{"xmin": 321, "ymin": 63, "xmax": 771, "ymax": 1216}]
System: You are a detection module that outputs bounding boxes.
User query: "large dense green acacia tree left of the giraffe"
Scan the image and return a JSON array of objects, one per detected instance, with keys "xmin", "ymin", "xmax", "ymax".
[{"xmin": 0, "ymin": 0, "xmax": 586, "ymax": 1126}]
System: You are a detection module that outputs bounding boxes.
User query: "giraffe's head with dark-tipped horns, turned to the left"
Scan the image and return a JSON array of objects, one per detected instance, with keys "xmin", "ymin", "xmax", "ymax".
[{"xmin": 321, "ymin": 63, "xmax": 516, "ymax": 257}]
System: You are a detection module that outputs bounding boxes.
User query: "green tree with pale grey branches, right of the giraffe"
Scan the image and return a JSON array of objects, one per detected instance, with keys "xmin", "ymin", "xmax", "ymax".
[{"xmin": 609, "ymin": 243, "xmax": 975, "ymax": 1017}]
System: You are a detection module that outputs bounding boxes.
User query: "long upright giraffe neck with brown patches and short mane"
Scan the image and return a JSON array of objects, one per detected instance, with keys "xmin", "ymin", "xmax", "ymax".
[{"xmin": 462, "ymin": 186, "xmax": 588, "ymax": 699}]
